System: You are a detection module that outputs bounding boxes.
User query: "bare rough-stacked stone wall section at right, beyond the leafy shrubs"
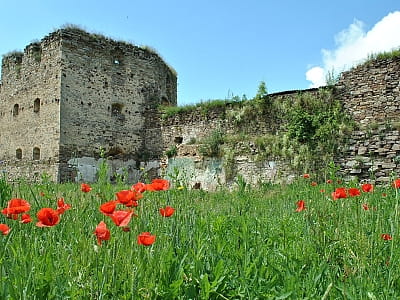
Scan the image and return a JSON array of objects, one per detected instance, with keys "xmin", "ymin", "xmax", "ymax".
[{"xmin": 337, "ymin": 57, "xmax": 400, "ymax": 183}]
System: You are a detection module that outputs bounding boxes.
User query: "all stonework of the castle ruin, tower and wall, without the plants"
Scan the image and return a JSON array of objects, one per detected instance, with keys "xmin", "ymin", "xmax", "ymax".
[{"xmin": 0, "ymin": 28, "xmax": 400, "ymax": 189}]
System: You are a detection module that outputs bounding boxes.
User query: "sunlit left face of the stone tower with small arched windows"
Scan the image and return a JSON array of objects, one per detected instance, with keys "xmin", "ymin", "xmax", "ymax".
[{"xmin": 0, "ymin": 34, "xmax": 61, "ymax": 179}]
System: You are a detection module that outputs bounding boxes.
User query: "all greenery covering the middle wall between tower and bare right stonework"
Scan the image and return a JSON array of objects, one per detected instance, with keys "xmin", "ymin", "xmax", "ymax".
[{"xmin": 173, "ymin": 88, "xmax": 354, "ymax": 178}]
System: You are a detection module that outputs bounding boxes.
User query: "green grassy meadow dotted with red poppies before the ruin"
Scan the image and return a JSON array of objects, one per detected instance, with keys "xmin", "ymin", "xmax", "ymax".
[{"xmin": 0, "ymin": 174, "xmax": 400, "ymax": 299}]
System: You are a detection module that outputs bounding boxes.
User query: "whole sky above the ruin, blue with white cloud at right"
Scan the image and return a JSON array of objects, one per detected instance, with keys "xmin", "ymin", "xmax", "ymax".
[{"xmin": 0, "ymin": 0, "xmax": 400, "ymax": 105}]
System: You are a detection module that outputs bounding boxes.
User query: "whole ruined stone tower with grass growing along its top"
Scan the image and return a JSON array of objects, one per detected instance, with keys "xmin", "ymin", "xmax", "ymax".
[{"xmin": 0, "ymin": 28, "xmax": 177, "ymax": 182}]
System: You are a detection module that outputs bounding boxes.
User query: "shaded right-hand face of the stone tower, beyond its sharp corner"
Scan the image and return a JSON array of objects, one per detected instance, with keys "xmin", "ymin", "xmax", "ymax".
[{"xmin": 57, "ymin": 30, "xmax": 176, "ymax": 179}]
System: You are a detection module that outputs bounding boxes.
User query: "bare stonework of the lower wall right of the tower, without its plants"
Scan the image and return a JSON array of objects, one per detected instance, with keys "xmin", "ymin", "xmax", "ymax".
[{"xmin": 162, "ymin": 57, "xmax": 400, "ymax": 189}]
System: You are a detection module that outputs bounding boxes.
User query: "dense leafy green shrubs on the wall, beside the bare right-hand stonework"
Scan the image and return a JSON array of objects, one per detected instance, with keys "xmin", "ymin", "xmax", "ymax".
[{"xmin": 256, "ymin": 89, "xmax": 353, "ymax": 171}]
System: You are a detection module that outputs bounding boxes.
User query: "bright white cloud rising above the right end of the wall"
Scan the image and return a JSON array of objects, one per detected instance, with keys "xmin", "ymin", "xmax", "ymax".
[{"xmin": 306, "ymin": 11, "xmax": 400, "ymax": 87}]
